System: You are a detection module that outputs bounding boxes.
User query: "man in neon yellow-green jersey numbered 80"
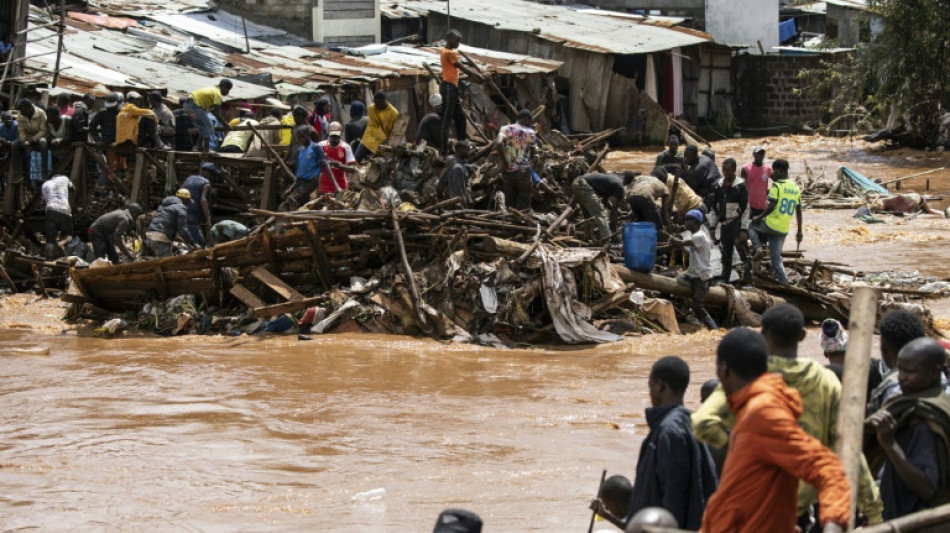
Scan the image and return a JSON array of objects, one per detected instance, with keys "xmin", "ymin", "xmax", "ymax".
[{"xmin": 750, "ymin": 159, "xmax": 804, "ymax": 285}]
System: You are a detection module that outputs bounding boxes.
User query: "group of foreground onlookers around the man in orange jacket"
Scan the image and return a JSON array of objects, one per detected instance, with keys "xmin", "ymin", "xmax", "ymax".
[{"xmin": 412, "ymin": 304, "xmax": 950, "ymax": 533}]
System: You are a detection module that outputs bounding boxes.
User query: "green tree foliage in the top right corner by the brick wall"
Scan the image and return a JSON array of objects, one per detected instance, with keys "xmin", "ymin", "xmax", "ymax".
[{"xmin": 803, "ymin": 0, "xmax": 950, "ymax": 140}]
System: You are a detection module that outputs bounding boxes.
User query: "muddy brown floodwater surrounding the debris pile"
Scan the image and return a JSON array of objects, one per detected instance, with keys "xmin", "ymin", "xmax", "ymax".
[{"xmin": 0, "ymin": 138, "xmax": 950, "ymax": 533}]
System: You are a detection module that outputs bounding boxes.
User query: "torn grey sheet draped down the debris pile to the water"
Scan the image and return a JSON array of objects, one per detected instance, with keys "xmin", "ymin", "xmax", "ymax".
[{"xmin": 538, "ymin": 244, "xmax": 622, "ymax": 344}]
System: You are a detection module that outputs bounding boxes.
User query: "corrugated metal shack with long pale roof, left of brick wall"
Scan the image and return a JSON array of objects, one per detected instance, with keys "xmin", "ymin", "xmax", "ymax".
[{"xmin": 384, "ymin": 0, "xmax": 732, "ymax": 140}]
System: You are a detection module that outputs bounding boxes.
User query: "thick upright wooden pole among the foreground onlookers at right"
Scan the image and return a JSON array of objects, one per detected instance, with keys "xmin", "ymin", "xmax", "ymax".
[{"xmin": 835, "ymin": 287, "xmax": 879, "ymax": 530}]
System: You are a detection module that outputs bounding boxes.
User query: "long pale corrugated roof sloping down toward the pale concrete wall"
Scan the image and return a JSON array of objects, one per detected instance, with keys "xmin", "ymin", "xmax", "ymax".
[{"xmin": 390, "ymin": 0, "xmax": 712, "ymax": 54}]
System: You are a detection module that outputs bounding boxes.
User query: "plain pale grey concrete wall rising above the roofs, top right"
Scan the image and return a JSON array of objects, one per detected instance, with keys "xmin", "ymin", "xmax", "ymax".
[{"xmin": 706, "ymin": 0, "xmax": 779, "ymax": 54}]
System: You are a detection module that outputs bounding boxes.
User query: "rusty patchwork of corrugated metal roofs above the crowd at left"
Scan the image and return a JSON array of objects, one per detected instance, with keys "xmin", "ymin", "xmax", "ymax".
[{"xmin": 13, "ymin": 4, "xmax": 561, "ymax": 138}]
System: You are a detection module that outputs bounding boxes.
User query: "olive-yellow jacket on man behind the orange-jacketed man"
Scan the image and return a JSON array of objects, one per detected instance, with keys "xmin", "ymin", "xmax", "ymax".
[{"xmin": 692, "ymin": 356, "xmax": 884, "ymax": 524}]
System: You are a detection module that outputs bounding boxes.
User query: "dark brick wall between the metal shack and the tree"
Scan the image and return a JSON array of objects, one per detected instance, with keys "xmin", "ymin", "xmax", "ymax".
[{"xmin": 732, "ymin": 54, "xmax": 843, "ymax": 128}]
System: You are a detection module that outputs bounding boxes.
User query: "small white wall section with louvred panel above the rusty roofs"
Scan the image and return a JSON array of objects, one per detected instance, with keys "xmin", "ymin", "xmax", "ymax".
[{"xmin": 313, "ymin": 0, "xmax": 381, "ymax": 46}]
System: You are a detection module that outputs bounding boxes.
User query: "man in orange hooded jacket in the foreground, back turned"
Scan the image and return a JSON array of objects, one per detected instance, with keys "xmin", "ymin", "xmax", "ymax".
[{"xmin": 701, "ymin": 329, "xmax": 851, "ymax": 533}]
